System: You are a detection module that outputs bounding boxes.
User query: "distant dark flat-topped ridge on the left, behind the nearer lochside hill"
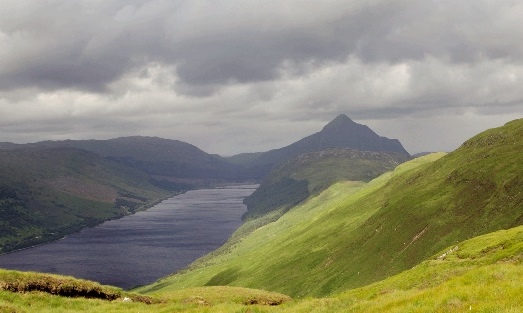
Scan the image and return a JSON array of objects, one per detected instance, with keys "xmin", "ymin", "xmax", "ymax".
[{"xmin": 0, "ymin": 136, "xmax": 248, "ymax": 183}]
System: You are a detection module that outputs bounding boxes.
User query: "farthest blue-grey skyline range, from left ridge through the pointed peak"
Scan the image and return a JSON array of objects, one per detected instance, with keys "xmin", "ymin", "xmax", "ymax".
[{"xmin": 0, "ymin": 114, "xmax": 410, "ymax": 183}]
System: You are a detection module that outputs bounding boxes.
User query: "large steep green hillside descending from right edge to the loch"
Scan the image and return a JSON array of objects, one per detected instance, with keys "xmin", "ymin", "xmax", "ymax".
[{"xmin": 143, "ymin": 120, "xmax": 523, "ymax": 296}]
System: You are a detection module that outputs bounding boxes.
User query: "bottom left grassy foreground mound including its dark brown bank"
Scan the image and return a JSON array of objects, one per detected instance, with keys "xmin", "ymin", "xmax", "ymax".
[{"xmin": 0, "ymin": 270, "xmax": 291, "ymax": 313}]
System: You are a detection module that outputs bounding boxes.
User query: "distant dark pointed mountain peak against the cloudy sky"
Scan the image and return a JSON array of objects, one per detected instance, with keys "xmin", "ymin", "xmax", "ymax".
[{"xmin": 227, "ymin": 114, "xmax": 409, "ymax": 178}]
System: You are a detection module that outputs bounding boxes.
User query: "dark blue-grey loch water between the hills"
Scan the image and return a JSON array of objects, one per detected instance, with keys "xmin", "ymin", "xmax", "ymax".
[{"xmin": 0, "ymin": 185, "xmax": 257, "ymax": 289}]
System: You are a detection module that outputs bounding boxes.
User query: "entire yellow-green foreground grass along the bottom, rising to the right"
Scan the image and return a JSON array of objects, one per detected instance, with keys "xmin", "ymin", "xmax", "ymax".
[{"xmin": 0, "ymin": 226, "xmax": 523, "ymax": 313}]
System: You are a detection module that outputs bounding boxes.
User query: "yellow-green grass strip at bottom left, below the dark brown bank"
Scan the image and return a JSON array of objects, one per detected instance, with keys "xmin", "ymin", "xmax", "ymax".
[{"xmin": 0, "ymin": 287, "xmax": 291, "ymax": 313}]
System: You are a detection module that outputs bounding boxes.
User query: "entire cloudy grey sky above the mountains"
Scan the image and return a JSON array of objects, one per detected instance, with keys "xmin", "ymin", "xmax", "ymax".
[{"xmin": 0, "ymin": 0, "xmax": 523, "ymax": 155}]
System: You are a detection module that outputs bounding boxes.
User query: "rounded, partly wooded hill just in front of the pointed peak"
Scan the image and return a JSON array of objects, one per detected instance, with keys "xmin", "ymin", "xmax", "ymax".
[{"xmin": 244, "ymin": 148, "xmax": 409, "ymax": 218}]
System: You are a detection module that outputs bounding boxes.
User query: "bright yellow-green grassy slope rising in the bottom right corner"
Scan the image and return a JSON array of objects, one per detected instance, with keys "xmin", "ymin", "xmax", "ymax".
[{"xmin": 283, "ymin": 226, "xmax": 523, "ymax": 312}]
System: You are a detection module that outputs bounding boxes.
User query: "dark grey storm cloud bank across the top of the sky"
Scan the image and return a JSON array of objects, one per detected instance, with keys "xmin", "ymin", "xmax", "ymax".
[{"xmin": 0, "ymin": 0, "xmax": 521, "ymax": 91}]
